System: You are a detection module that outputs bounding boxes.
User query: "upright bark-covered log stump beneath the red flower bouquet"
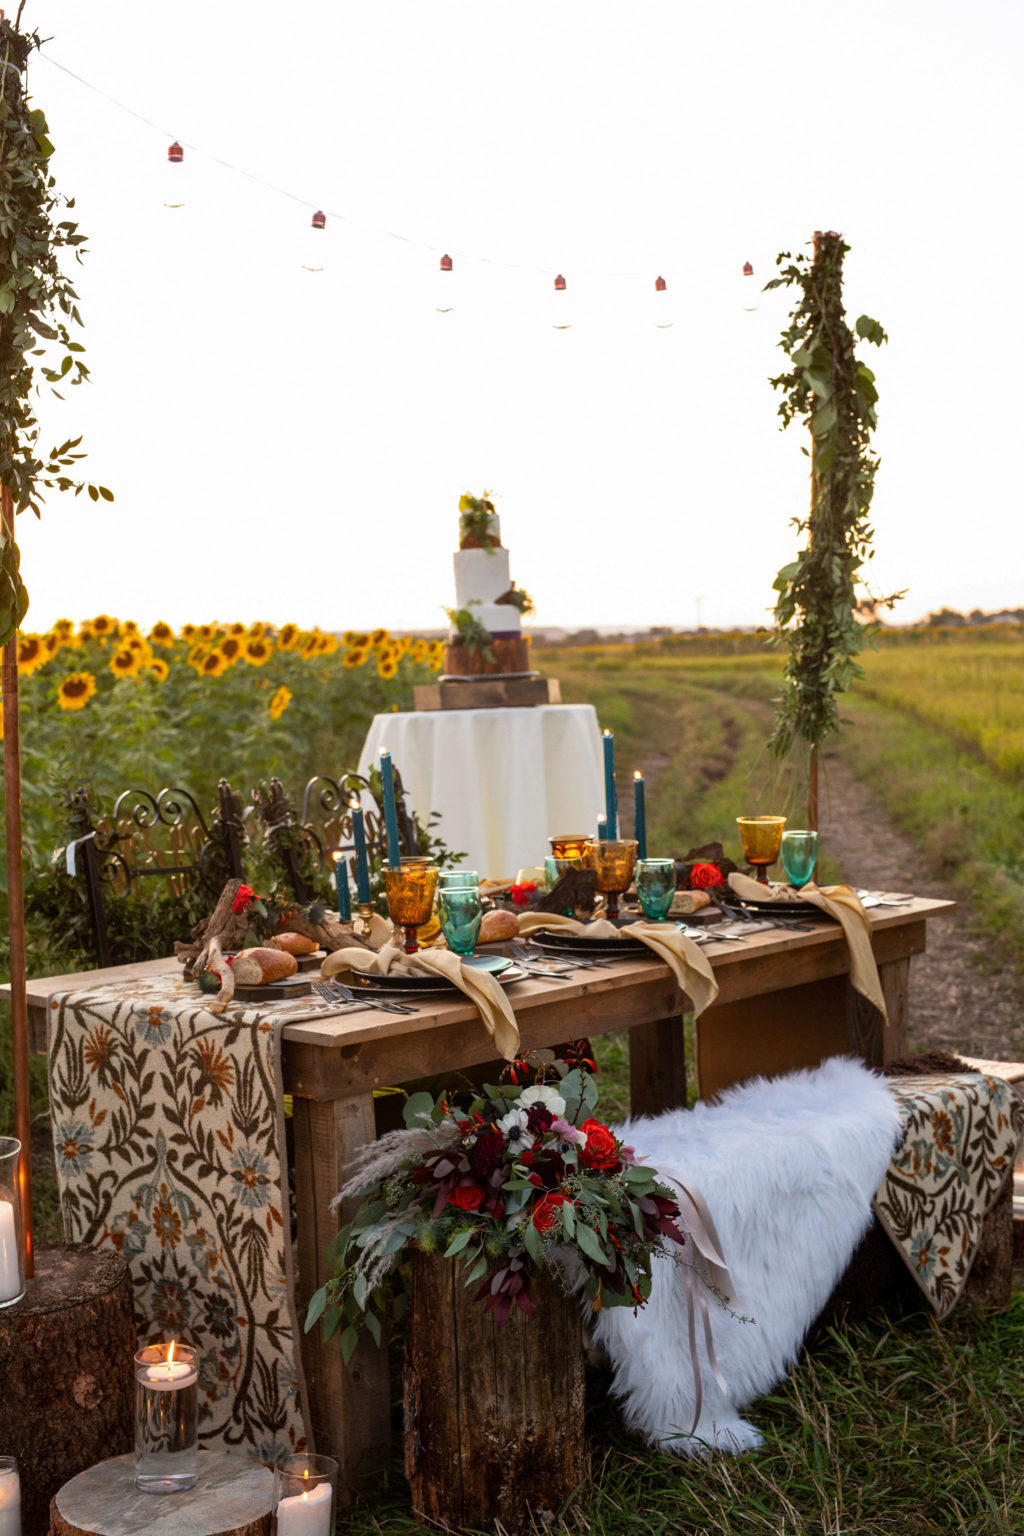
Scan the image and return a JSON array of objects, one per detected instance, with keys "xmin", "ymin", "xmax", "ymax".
[{"xmin": 405, "ymin": 1253, "xmax": 583, "ymax": 1536}]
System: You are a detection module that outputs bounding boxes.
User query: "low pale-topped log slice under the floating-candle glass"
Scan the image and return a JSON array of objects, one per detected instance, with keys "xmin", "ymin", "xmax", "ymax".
[{"xmin": 49, "ymin": 1450, "xmax": 273, "ymax": 1536}]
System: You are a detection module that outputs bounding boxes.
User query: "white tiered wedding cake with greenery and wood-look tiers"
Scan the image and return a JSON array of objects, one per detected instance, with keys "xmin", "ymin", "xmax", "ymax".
[{"xmin": 445, "ymin": 496, "xmax": 530, "ymax": 677}]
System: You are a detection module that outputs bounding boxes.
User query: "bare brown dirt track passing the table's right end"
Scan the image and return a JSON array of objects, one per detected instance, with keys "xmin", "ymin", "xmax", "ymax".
[{"xmin": 821, "ymin": 737, "xmax": 1024, "ymax": 1061}]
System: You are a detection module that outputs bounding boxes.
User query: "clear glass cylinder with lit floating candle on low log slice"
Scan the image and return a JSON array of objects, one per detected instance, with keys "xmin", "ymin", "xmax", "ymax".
[{"xmin": 135, "ymin": 1342, "xmax": 200, "ymax": 1493}]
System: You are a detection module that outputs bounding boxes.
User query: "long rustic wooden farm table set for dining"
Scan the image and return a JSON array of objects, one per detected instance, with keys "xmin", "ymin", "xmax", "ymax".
[{"xmin": 14, "ymin": 897, "xmax": 955, "ymax": 1488}]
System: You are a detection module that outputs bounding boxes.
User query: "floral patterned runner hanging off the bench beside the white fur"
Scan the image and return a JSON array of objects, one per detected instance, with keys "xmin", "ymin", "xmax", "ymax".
[{"xmin": 875, "ymin": 1074, "xmax": 1024, "ymax": 1318}]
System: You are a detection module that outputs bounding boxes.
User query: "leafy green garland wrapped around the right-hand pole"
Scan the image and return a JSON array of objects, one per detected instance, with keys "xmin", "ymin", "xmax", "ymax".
[{"xmin": 766, "ymin": 230, "xmax": 903, "ymax": 757}]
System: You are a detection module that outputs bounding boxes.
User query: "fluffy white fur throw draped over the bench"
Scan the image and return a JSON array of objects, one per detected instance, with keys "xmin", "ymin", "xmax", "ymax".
[{"xmin": 594, "ymin": 1057, "xmax": 900, "ymax": 1456}]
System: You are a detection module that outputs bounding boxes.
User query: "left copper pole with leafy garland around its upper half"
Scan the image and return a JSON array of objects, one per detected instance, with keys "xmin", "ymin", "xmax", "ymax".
[{"xmin": 0, "ymin": 8, "xmax": 114, "ymax": 1275}]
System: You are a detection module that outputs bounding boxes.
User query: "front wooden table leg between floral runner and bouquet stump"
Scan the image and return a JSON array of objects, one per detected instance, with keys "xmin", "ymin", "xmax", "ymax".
[{"xmin": 295, "ymin": 1094, "xmax": 391, "ymax": 1502}]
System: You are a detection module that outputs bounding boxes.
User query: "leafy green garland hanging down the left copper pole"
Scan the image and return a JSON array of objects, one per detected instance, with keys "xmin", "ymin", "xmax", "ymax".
[{"xmin": 0, "ymin": 11, "xmax": 114, "ymax": 645}]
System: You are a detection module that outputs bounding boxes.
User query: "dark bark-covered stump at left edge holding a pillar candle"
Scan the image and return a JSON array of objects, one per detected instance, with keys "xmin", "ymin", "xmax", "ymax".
[{"xmin": 0, "ymin": 1243, "xmax": 135, "ymax": 1536}]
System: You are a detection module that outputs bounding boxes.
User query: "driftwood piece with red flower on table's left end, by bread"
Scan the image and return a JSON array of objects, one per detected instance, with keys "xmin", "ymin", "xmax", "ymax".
[{"xmin": 173, "ymin": 880, "xmax": 368, "ymax": 1014}]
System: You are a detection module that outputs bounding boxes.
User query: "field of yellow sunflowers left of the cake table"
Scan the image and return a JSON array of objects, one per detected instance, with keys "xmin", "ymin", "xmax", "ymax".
[{"xmin": 0, "ymin": 613, "xmax": 444, "ymax": 969}]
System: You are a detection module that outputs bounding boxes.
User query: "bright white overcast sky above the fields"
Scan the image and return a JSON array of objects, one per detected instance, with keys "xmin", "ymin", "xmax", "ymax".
[{"xmin": 18, "ymin": 0, "xmax": 1024, "ymax": 630}]
